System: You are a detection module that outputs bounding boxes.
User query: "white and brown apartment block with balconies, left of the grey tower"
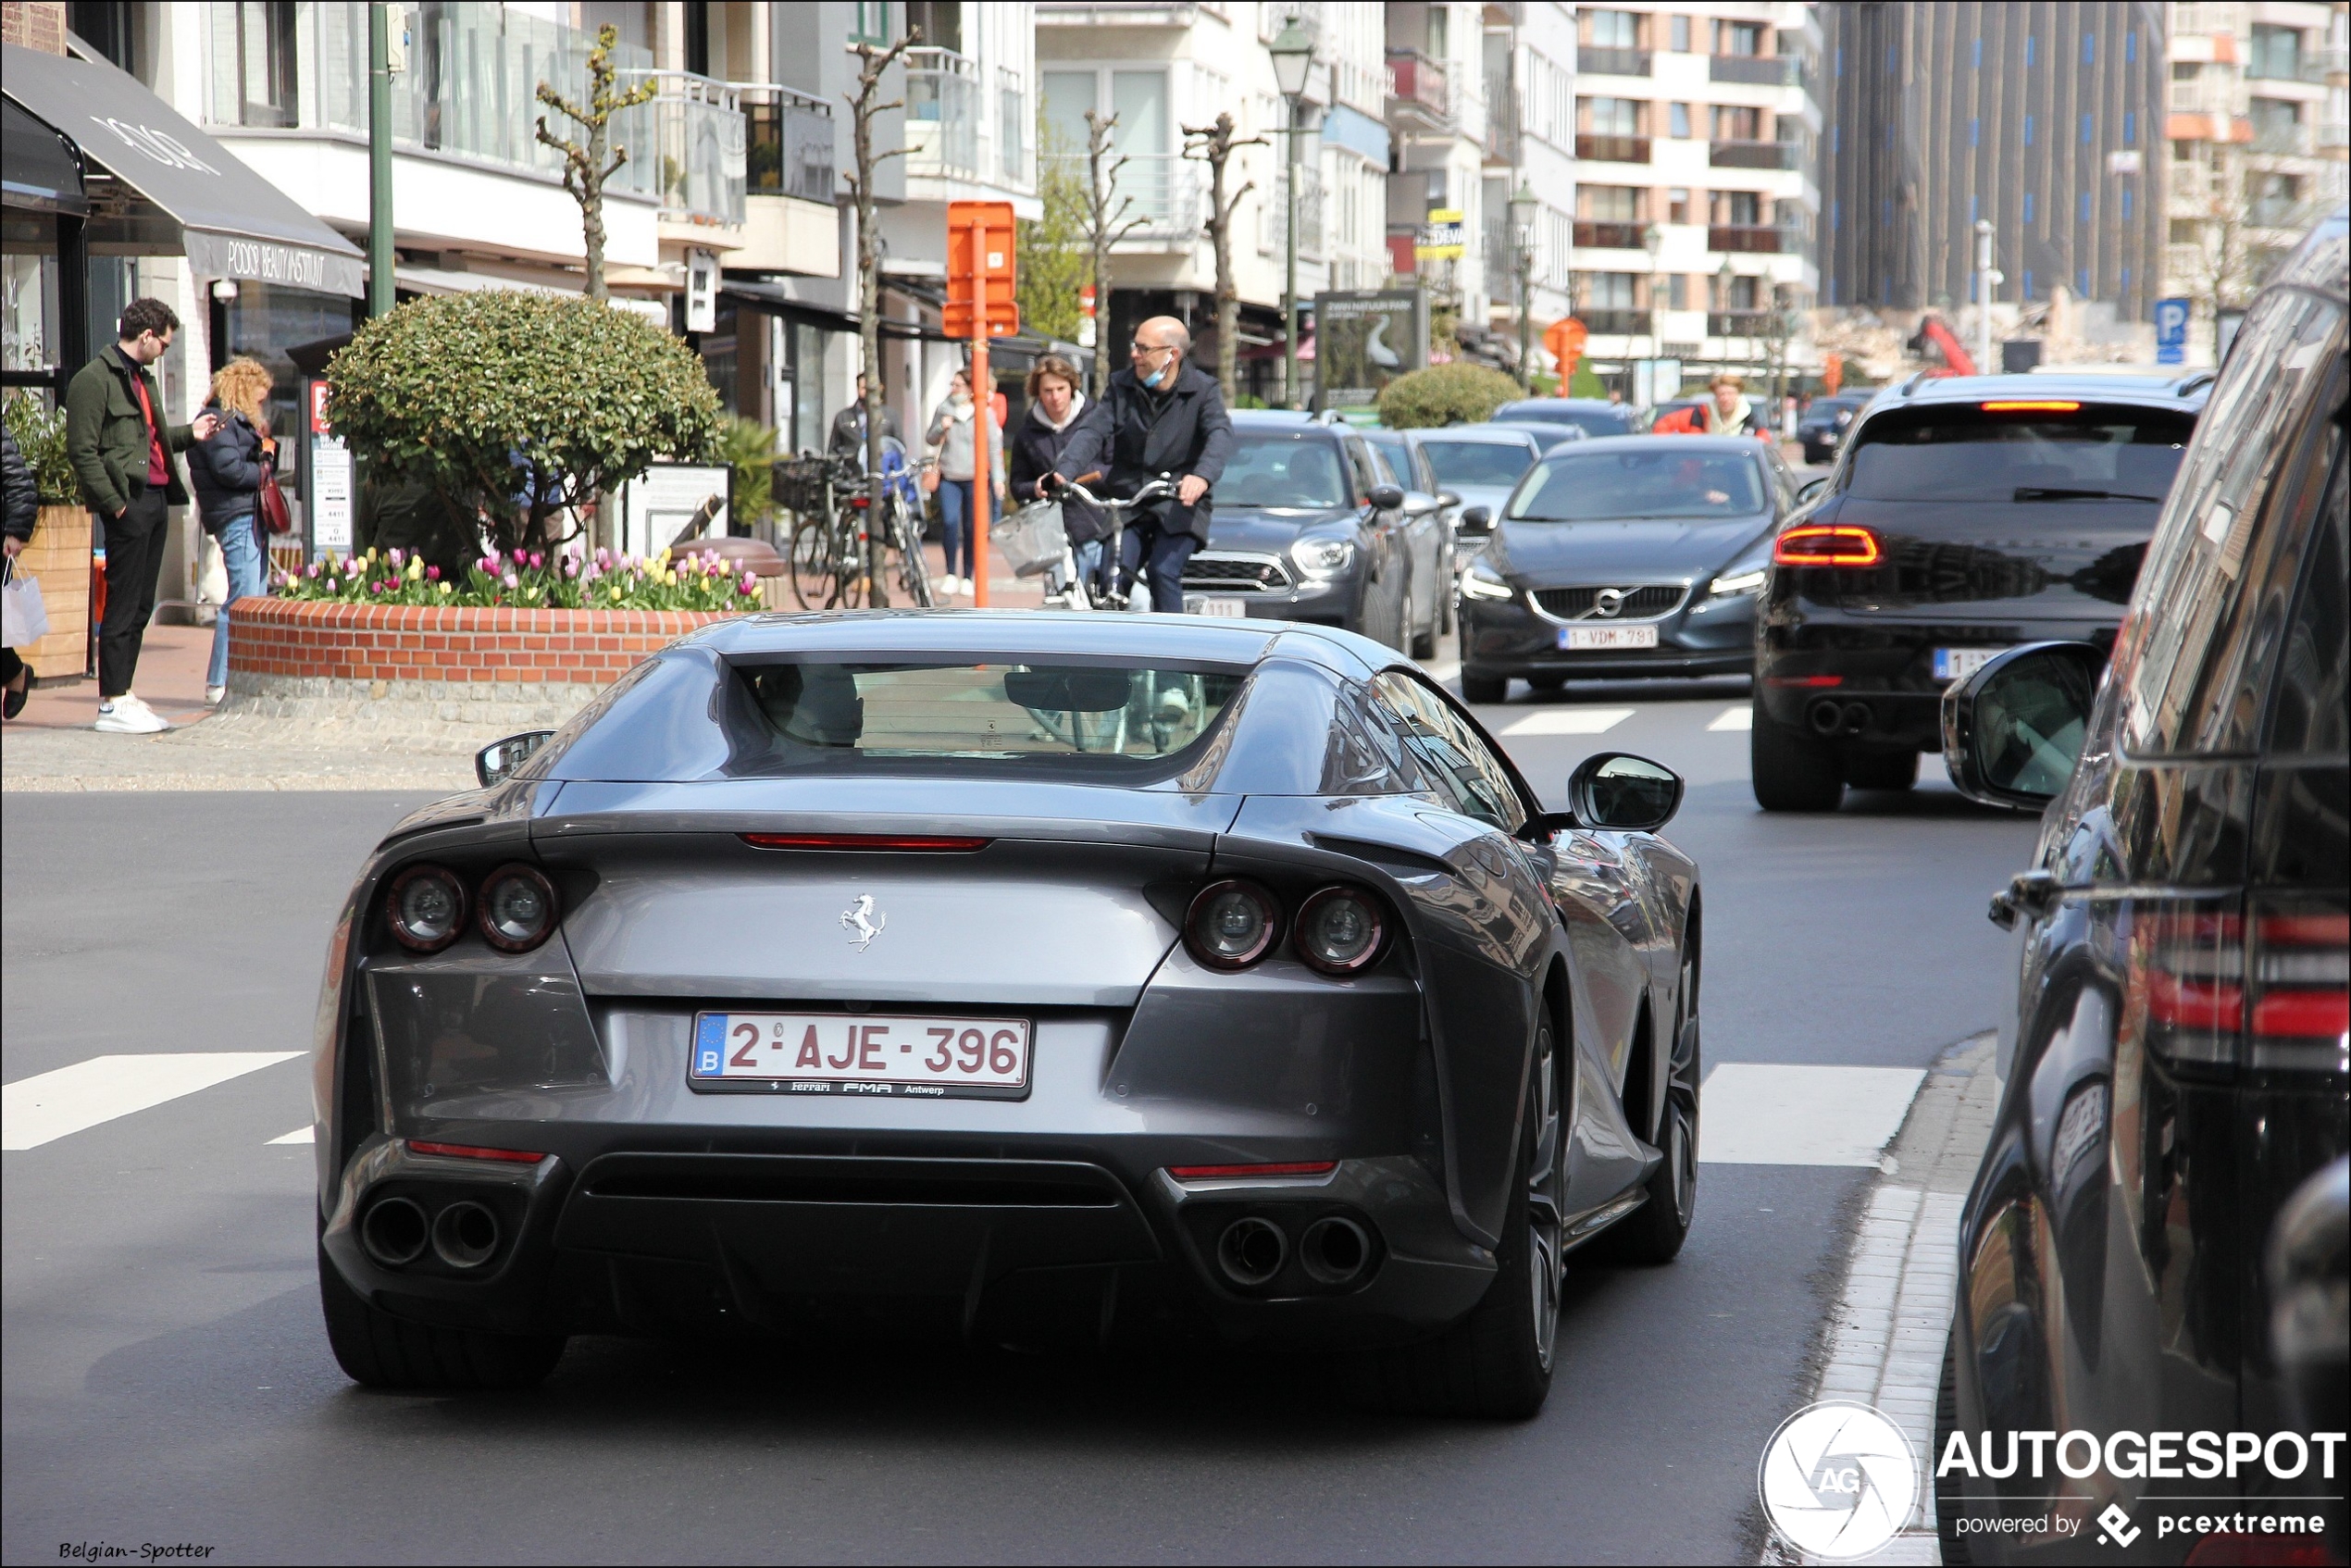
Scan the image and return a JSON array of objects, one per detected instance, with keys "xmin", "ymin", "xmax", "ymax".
[{"xmin": 1571, "ymin": 3, "xmax": 1834, "ymax": 395}]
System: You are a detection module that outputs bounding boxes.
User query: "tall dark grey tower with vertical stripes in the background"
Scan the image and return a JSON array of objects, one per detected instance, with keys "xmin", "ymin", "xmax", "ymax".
[{"xmin": 1822, "ymin": 0, "xmax": 2165, "ymax": 345}]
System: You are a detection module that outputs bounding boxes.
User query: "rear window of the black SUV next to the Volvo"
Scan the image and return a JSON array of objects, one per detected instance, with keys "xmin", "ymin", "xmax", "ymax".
[{"xmin": 1846, "ymin": 406, "xmax": 2196, "ymax": 504}]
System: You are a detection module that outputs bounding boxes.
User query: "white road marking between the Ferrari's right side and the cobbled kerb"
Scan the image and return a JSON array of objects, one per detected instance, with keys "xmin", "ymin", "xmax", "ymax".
[{"xmin": 1698, "ymin": 1063, "xmax": 1925, "ymax": 1166}]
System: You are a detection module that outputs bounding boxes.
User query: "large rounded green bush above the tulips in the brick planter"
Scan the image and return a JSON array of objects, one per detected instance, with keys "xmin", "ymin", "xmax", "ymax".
[{"xmin": 327, "ymin": 289, "xmax": 719, "ymax": 553}]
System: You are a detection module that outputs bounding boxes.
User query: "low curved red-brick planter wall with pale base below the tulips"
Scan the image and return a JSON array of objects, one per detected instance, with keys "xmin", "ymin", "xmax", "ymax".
[{"xmin": 212, "ymin": 597, "xmax": 731, "ymax": 743}]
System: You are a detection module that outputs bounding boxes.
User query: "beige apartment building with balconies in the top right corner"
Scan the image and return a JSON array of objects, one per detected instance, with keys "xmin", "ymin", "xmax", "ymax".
[{"xmin": 2160, "ymin": 0, "xmax": 2351, "ymax": 365}]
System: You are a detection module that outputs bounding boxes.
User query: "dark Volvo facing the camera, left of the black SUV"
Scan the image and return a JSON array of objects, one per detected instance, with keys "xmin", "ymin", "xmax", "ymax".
[{"xmin": 1460, "ymin": 435, "xmax": 1797, "ymax": 703}]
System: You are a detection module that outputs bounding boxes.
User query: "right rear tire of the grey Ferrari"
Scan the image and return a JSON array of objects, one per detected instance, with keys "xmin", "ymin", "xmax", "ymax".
[{"xmin": 1362, "ymin": 1018, "xmax": 1566, "ymax": 1420}]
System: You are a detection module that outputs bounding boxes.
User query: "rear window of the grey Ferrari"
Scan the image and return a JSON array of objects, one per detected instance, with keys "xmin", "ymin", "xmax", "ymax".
[{"xmin": 736, "ymin": 661, "xmax": 1244, "ymax": 774}]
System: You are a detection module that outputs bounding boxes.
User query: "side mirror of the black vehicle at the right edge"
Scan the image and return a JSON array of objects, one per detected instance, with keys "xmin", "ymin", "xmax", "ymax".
[{"xmin": 1942, "ymin": 641, "xmax": 2107, "ymax": 811}]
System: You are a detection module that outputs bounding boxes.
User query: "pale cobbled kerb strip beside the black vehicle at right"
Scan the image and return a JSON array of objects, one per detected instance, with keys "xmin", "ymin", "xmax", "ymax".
[{"xmin": 1766, "ymin": 1034, "xmax": 1998, "ymax": 1563}]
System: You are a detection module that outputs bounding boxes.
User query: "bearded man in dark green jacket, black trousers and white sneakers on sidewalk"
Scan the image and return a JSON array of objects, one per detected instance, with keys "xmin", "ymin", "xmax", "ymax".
[{"xmin": 66, "ymin": 299, "xmax": 221, "ymax": 736}]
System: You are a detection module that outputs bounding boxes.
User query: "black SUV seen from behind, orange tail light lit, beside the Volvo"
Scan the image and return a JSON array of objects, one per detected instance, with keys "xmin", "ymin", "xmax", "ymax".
[{"xmin": 1751, "ymin": 371, "xmax": 2212, "ymax": 811}]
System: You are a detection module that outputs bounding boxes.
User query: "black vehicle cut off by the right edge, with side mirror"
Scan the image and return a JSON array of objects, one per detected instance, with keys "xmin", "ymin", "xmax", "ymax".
[{"xmin": 1934, "ymin": 214, "xmax": 2351, "ymax": 1563}]
